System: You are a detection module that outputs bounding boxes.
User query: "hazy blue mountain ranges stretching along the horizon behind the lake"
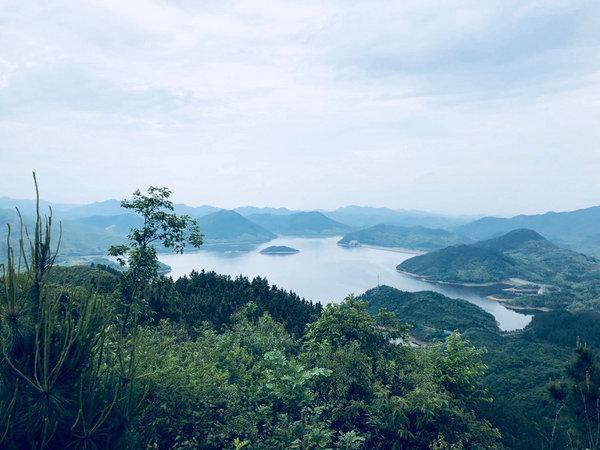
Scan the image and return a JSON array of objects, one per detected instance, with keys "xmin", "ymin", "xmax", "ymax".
[{"xmin": 0, "ymin": 197, "xmax": 600, "ymax": 264}]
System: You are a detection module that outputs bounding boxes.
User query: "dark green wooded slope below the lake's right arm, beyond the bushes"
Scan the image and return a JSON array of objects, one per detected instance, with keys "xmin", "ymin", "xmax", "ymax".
[{"xmin": 361, "ymin": 286, "xmax": 600, "ymax": 449}]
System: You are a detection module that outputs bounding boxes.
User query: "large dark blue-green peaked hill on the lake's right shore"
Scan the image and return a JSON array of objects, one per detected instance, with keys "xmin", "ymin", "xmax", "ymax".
[{"xmin": 398, "ymin": 229, "xmax": 600, "ymax": 285}]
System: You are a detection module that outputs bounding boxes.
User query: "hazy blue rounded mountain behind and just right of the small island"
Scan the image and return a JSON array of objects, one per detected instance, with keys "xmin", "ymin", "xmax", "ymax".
[{"xmin": 248, "ymin": 211, "xmax": 350, "ymax": 236}]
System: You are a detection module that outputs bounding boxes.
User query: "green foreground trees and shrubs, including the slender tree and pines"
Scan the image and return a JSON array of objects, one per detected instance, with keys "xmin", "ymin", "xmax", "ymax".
[{"xmin": 0, "ymin": 178, "xmax": 600, "ymax": 449}]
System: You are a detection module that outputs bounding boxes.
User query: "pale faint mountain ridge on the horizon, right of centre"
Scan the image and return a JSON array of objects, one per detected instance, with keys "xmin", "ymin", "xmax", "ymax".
[{"xmin": 324, "ymin": 205, "xmax": 473, "ymax": 228}]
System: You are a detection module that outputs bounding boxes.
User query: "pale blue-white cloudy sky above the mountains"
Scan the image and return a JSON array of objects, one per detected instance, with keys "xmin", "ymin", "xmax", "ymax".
[{"xmin": 0, "ymin": 0, "xmax": 600, "ymax": 215}]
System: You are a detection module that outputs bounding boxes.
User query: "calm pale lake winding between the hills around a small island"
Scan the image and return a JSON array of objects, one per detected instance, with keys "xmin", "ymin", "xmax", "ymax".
[{"xmin": 159, "ymin": 237, "xmax": 531, "ymax": 331}]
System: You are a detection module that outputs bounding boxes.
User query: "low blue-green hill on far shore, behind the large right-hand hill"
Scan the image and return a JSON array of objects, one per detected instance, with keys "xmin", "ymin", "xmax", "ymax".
[{"xmin": 338, "ymin": 224, "xmax": 472, "ymax": 252}]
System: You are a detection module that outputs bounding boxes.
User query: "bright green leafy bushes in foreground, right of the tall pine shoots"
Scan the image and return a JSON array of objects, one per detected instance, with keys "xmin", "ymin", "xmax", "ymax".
[{"xmin": 124, "ymin": 299, "xmax": 497, "ymax": 449}]
